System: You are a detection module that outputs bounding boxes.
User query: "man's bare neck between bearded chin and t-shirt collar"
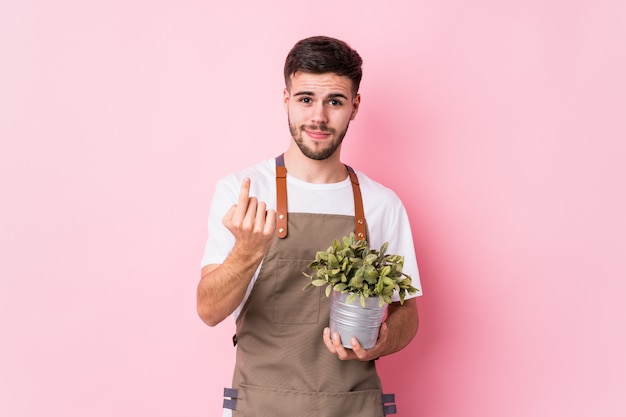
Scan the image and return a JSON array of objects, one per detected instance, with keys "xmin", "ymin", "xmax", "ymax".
[{"xmin": 285, "ymin": 146, "xmax": 348, "ymax": 184}]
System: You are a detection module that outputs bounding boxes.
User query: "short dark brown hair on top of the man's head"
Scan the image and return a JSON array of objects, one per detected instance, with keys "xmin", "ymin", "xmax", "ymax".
[{"xmin": 285, "ymin": 36, "xmax": 363, "ymax": 96}]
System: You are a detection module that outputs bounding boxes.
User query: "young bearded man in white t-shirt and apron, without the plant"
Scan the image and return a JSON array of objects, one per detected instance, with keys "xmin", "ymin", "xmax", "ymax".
[{"xmin": 197, "ymin": 36, "xmax": 421, "ymax": 417}]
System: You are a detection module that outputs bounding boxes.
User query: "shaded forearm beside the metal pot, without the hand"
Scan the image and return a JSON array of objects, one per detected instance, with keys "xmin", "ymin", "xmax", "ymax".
[{"xmin": 381, "ymin": 298, "xmax": 419, "ymax": 356}]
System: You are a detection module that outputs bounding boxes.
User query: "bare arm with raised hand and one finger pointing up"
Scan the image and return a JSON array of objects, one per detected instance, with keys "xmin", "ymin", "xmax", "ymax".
[{"xmin": 196, "ymin": 178, "xmax": 276, "ymax": 326}]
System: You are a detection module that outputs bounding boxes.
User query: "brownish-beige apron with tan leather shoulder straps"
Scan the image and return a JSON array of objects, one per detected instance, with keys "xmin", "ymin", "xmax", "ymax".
[{"xmin": 224, "ymin": 155, "xmax": 395, "ymax": 417}]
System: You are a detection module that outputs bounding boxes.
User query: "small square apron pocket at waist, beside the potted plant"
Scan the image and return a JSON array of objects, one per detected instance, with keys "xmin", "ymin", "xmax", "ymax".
[{"xmin": 272, "ymin": 259, "xmax": 326, "ymax": 324}]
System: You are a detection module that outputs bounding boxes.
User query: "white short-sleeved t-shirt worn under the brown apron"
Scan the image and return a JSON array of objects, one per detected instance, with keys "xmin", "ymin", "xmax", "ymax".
[{"xmin": 201, "ymin": 159, "xmax": 422, "ymax": 319}]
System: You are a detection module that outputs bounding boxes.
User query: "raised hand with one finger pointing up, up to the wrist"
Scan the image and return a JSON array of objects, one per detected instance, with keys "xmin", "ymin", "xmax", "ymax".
[{"xmin": 222, "ymin": 178, "xmax": 276, "ymax": 255}]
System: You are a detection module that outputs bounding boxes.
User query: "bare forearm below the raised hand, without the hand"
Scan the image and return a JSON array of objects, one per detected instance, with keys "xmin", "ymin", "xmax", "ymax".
[{"xmin": 197, "ymin": 247, "xmax": 263, "ymax": 326}]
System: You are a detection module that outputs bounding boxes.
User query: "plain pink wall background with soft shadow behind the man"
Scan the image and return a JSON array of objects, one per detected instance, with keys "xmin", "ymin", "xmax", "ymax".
[{"xmin": 0, "ymin": 0, "xmax": 626, "ymax": 417}]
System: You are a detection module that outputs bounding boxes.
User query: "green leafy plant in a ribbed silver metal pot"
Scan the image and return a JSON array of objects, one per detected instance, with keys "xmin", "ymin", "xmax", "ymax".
[{"xmin": 303, "ymin": 233, "xmax": 418, "ymax": 349}]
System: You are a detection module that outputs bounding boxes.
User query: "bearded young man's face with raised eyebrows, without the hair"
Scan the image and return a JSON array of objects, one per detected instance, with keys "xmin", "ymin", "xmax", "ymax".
[{"xmin": 284, "ymin": 72, "xmax": 361, "ymax": 160}]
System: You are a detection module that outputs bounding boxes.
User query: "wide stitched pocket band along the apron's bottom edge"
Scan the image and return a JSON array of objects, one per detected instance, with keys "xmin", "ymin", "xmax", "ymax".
[{"xmin": 233, "ymin": 384, "xmax": 383, "ymax": 417}]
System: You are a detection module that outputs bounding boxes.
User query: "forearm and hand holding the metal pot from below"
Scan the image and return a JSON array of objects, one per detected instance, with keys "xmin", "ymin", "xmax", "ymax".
[{"xmin": 323, "ymin": 298, "xmax": 419, "ymax": 361}]
